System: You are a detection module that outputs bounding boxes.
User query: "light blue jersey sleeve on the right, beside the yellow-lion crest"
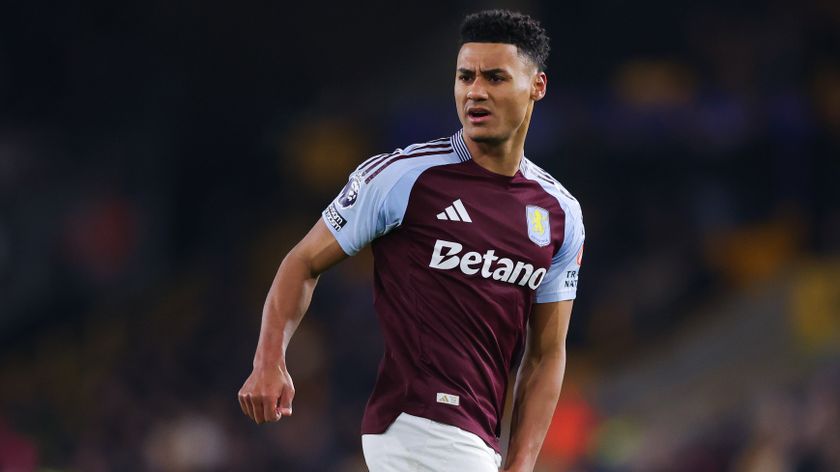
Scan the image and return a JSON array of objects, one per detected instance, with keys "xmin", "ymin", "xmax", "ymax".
[{"xmin": 536, "ymin": 200, "xmax": 586, "ymax": 303}]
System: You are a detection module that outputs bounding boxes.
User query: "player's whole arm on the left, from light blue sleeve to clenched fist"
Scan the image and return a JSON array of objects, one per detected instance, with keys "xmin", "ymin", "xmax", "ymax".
[{"xmin": 239, "ymin": 153, "xmax": 416, "ymax": 424}]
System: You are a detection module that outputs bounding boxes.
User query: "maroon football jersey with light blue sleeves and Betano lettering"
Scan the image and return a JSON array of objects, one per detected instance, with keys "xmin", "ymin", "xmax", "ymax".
[{"xmin": 322, "ymin": 130, "xmax": 584, "ymax": 451}]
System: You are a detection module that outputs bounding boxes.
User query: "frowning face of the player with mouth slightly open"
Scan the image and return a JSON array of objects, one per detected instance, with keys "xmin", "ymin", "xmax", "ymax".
[{"xmin": 455, "ymin": 43, "xmax": 546, "ymax": 143}]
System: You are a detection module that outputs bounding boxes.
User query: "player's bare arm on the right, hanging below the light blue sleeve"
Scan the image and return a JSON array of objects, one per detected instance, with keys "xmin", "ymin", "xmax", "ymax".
[{"xmin": 503, "ymin": 300, "xmax": 573, "ymax": 472}]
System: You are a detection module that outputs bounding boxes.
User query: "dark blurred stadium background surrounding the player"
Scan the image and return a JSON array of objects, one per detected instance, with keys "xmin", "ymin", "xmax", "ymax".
[{"xmin": 0, "ymin": 0, "xmax": 840, "ymax": 472}]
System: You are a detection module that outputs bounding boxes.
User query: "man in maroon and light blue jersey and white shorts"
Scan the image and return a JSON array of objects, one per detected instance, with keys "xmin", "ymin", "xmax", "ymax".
[{"xmin": 239, "ymin": 10, "xmax": 584, "ymax": 472}]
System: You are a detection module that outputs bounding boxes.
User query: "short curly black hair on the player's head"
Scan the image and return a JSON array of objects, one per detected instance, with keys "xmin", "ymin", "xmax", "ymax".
[{"xmin": 460, "ymin": 10, "xmax": 551, "ymax": 71}]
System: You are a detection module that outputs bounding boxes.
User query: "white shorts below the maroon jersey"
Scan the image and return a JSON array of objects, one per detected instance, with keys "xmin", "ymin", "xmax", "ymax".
[{"xmin": 362, "ymin": 413, "xmax": 502, "ymax": 472}]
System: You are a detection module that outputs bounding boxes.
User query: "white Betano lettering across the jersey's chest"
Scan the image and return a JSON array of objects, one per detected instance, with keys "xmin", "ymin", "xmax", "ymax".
[{"xmin": 429, "ymin": 239, "xmax": 546, "ymax": 290}]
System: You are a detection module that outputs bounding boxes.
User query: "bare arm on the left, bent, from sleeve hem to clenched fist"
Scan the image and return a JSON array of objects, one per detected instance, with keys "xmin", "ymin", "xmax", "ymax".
[{"xmin": 239, "ymin": 219, "xmax": 347, "ymax": 424}]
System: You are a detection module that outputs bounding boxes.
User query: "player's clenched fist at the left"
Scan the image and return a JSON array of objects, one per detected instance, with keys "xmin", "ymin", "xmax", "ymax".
[{"xmin": 239, "ymin": 366, "xmax": 295, "ymax": 424}]
